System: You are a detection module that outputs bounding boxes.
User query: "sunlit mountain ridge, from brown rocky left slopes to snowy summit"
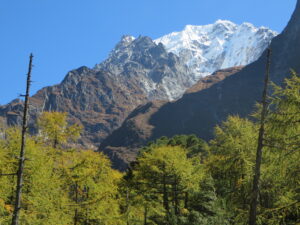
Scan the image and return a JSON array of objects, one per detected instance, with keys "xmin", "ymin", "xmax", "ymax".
[{"xmin": 0, "ymin": 21, "xmax": 276, "ymax": 149}]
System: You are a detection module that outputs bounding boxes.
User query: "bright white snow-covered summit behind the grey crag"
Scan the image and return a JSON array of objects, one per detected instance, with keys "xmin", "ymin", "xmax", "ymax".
[{"xmin": 155, "ymin": 20, "xmax": 277, "ymax": 80}]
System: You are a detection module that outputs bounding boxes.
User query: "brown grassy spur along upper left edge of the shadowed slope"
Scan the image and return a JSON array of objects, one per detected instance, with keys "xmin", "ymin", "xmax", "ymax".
[{"xmin": 100, "ymin": 67, "xmax": 243, "ymax": 170}]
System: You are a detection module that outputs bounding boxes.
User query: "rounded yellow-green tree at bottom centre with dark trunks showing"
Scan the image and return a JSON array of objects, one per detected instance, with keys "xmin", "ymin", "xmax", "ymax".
[{"xmin": 124, "ymin": 146, "xmax": 203, "ymax": 224}]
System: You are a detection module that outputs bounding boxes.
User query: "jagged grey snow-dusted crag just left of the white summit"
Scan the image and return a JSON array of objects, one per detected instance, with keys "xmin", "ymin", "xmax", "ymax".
[{"xmin": 95, "ymin": 36, "xmax": 193, "ymax": 100}]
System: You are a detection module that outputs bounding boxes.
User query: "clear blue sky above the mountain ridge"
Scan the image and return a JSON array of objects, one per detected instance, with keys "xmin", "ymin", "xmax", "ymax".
[{"xmin": 0, "ymin": 0, "xmax": 296, "ymax": 104}]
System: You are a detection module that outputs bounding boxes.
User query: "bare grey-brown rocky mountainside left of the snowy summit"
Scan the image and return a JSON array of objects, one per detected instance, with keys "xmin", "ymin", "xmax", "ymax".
[{"xmin": 0, "ymin": 37, "xmax": 189, "ymax": 149}]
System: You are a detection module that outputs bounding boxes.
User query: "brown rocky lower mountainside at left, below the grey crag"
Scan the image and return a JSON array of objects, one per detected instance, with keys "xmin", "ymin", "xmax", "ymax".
[{"xmin": 0, "ymin": 67, "xmax": 147, "ymax": 148}]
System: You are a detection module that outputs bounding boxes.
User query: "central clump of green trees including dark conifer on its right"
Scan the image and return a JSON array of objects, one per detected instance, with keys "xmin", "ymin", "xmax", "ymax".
[{"xmin": 123, "ymin": 143, "xmax": 223, "ymax": 224}]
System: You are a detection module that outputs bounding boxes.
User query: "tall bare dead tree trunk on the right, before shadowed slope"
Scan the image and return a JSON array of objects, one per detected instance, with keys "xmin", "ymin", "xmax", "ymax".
[{"xmin": 249, "ymin": 49, "xmax": 271, "ymax": 225}]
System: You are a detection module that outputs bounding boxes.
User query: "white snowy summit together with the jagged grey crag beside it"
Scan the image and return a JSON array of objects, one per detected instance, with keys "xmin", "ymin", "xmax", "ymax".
[{"xmin": 94, "ymin": 20, "xmax": 277, "ymax": 100}]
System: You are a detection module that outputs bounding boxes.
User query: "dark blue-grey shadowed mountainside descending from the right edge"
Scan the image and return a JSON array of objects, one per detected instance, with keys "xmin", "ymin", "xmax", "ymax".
[{"xmin": 100, "ymin": 0, "xmax": 300, "ymax": 168}]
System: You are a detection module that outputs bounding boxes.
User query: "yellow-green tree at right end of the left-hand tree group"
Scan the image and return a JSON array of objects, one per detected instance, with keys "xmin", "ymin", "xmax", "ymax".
[{"xmin": 58, "ymin": 150, "xmax": 123, "ymax": 225}]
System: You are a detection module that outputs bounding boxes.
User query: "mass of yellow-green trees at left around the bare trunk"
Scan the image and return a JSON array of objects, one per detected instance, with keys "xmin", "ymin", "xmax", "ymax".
[{"xmin": 0, "ymin": 116, "xmax": 124, "ymax": 225}]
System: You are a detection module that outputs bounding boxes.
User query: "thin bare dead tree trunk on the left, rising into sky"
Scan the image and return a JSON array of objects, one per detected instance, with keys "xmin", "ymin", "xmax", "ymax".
[{"xmin": 11, "ymin": 54, "xmax": 33, "ymax": 225}]
